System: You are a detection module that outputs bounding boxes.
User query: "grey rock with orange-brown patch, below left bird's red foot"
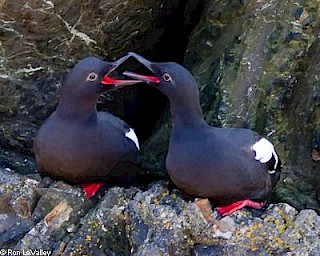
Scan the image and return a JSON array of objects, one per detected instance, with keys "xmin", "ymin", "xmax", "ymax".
[{"xmin": 14, "ymin": 182, "xmax": 93, "ymax": 250}]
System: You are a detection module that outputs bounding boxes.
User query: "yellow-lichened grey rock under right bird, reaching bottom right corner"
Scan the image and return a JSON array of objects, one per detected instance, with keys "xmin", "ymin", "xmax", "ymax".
[{"xmin": 58, "ymin": 182, "xmax": 320, "ymax": 255}]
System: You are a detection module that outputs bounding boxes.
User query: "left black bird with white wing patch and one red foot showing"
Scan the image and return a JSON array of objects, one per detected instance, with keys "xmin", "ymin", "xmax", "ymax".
[{"xmin": 34, "ymin": 56, "xmax": 139, "ymax": 198}]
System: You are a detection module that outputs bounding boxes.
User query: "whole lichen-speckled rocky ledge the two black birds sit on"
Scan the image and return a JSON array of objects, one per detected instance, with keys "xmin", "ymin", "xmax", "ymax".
[{"xmin": 0, "ymin": 168, "xmax": 320, "ymax": 255}]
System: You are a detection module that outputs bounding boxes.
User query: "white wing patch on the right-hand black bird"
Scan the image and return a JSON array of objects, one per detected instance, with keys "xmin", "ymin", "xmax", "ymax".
[{"xmin": 251, "ymin": 138, "xmax": 279, "ymax": 173}]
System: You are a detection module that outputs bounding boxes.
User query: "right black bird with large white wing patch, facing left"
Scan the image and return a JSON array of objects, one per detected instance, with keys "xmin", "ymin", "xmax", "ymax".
[{"xmin": 124, "ymin": 53, "xmax": 281, "ymax": 214}]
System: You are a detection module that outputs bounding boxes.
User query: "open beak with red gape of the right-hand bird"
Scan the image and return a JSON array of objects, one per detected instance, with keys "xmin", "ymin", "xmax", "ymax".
[{"xmin": 123, "ymin": 52, "xmax": 160, "ymax": 84}]
